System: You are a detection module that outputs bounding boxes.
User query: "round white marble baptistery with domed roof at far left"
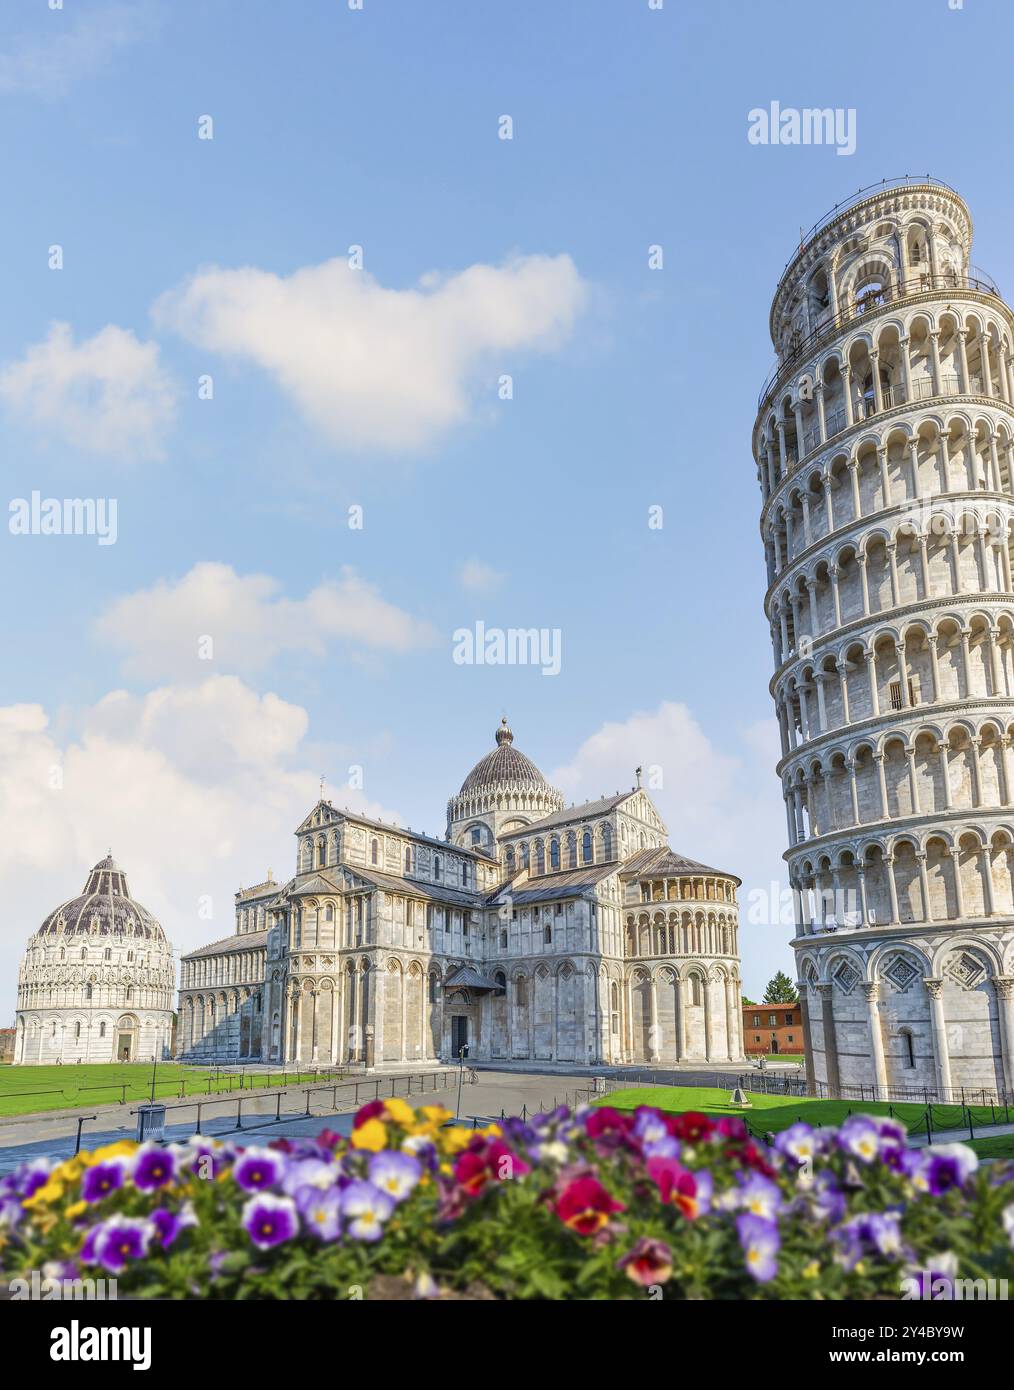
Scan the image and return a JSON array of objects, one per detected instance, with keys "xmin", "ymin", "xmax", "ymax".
[{"xmin": 14, "ymin": 855, "xmax": 175, "ymax": 1063}]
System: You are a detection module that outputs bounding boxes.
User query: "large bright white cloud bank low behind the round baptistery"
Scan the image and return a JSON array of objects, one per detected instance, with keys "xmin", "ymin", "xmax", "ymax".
[{"xmin": 0, "ymin": 677, "xmax": 395, "ymax": 1022}]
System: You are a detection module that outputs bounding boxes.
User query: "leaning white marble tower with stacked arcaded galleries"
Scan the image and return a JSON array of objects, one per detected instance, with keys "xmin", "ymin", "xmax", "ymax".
[{"xmin": 754, "ymin": 178, "xmax": 1014, "ymax": 1098}]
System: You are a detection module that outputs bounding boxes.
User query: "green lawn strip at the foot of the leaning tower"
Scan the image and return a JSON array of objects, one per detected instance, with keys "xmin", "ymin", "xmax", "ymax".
[{"xmin": 595, "ymin": 1086, "xmax": 1014, "ymax": 1143}]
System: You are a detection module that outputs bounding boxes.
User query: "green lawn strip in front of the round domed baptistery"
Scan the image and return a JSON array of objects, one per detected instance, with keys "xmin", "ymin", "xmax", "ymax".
[{"xmin": 0, "ymin": 1062, "xmax": 343, "ymax": 1115}]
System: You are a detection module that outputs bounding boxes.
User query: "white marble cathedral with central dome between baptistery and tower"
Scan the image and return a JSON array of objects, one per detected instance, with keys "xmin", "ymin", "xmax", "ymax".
[{"xmin": 177, "ymin": 720, "xmax": 743, "ymax": 1068}]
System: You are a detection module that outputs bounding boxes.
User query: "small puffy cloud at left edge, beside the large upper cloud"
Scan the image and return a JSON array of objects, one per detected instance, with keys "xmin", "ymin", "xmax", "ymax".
[{"xmin": 0, "ymin": 324, "xmax": 175, "ymax": 459}]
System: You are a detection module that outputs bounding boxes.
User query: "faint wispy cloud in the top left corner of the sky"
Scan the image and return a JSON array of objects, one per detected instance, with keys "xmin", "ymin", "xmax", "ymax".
[{"xmin": 0, "ymin": 0, "xmax": 157, "ymax": 97}]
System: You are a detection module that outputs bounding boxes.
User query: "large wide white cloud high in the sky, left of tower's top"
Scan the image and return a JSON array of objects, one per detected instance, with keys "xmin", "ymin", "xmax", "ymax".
[{"xmin": 153, "ymin": 248, "xmax": 587, "ymax": 449}]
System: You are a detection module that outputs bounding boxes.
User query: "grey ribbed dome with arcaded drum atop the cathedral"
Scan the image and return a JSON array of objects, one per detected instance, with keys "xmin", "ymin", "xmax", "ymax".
[{"xmin": 448, "ymin": 719, "xmax": 563, "ymax": 855}]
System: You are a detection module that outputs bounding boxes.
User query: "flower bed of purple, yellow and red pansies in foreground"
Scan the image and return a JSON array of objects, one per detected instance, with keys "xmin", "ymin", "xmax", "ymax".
[{"xmin": 0, "ymin": 1099, "xmax": 1014, "ymax": 1298}]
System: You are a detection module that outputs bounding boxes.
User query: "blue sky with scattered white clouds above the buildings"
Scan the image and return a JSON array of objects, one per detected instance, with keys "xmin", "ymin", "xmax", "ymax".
[{"xmin": 0, "ymin": 0, "xmax": 1014, "ymax": 1016}]
